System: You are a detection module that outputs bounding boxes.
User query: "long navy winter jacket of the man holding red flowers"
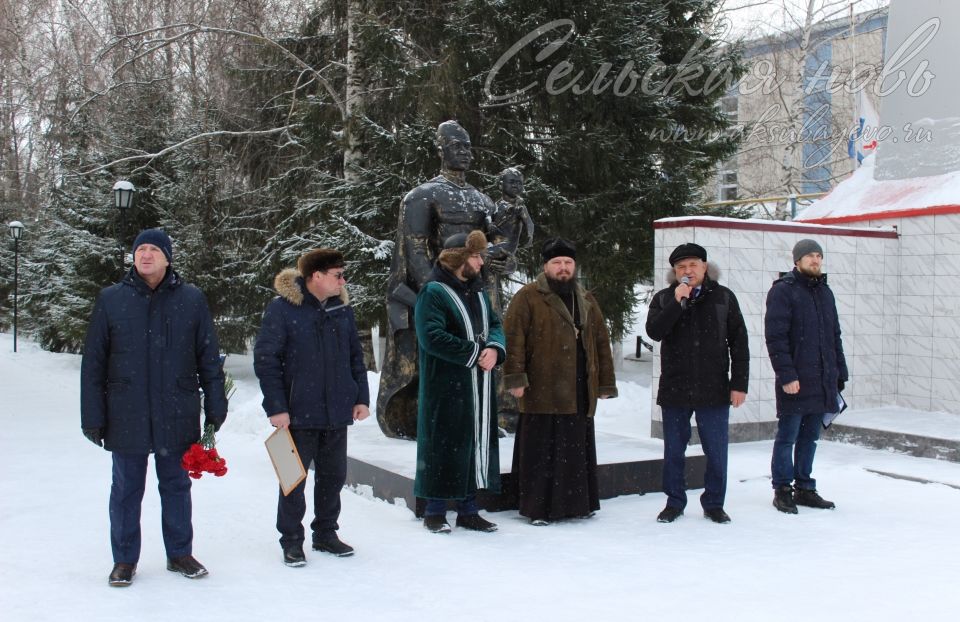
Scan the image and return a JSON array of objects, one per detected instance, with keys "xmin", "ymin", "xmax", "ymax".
[{"xmin": 80, "ymin": 268, "xmax": 227, "ymax": 455}]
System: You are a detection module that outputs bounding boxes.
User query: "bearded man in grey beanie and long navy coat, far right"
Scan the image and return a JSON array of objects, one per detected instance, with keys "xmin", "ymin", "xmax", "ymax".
[{"xmin": 764, "ymin": 240, "xmax": 848, "ymax": 514}]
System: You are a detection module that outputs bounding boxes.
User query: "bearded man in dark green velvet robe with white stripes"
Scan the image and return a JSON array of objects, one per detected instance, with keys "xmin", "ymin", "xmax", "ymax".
[{"xmin": 414, "ymin": 230, "xmax": 507, "ymax": 533}]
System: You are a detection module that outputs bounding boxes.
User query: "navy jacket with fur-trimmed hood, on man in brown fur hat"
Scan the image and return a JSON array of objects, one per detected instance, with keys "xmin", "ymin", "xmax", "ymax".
[{"xmin": 253, "ymin": 268, "xmax": 370, "ymax": 430}]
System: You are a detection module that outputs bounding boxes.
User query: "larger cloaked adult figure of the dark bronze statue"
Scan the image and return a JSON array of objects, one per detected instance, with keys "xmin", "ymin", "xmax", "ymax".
[{"xmin": 377, "ymin": 121, "xmax": 508, "ymax": 439}]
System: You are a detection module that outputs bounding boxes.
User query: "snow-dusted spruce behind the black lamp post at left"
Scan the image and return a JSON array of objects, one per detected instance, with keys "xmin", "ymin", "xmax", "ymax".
[{"xmin": 24, "ymin": 75, "xmax": 181, "ymax": 352}]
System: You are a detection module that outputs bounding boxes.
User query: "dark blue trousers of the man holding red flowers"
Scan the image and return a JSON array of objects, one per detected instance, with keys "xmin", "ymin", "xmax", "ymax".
[{"xmin": 110, "ymin": 452, "xmax": 193, "ymax": 564}]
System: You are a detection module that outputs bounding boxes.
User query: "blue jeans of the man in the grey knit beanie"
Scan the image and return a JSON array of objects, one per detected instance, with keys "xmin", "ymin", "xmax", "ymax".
[{"xmin": 770, "ymin": 413, "xmax": 823, "ymax": 490}]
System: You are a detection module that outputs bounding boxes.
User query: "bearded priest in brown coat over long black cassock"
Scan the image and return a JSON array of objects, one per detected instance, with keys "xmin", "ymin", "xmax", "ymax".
[{"xmin": 503, "ymin": 238, "xmax": 617, "ymax": 525}]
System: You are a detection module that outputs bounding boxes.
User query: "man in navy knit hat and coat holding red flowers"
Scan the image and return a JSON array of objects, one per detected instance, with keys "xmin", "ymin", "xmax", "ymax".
[{"xmin": 80, "ymin": 229, "xmax": 227, "ymax": 587}]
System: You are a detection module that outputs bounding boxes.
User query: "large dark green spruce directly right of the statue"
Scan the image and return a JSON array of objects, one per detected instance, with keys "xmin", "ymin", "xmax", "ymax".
[{"xmin": 443, "ymin": 0, "xmax": 744, "ymax": 339}]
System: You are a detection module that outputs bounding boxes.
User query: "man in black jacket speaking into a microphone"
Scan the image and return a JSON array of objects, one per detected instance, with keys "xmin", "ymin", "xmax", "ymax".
[{"xmin": 646, "ymin": 243, "xmax": 750, "ymax": 523}]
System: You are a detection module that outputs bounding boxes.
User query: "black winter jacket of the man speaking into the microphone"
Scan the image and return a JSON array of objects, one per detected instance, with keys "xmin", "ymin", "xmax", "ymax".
[{"xmin": 647, "ymin": 264, "xmax": 750, "ymax": 408}]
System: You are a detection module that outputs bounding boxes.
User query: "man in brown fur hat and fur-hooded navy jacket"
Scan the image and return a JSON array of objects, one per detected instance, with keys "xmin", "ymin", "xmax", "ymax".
[{"xmin": 253, "ymin": 248, "xmax": 370, "ymax": 567}]
